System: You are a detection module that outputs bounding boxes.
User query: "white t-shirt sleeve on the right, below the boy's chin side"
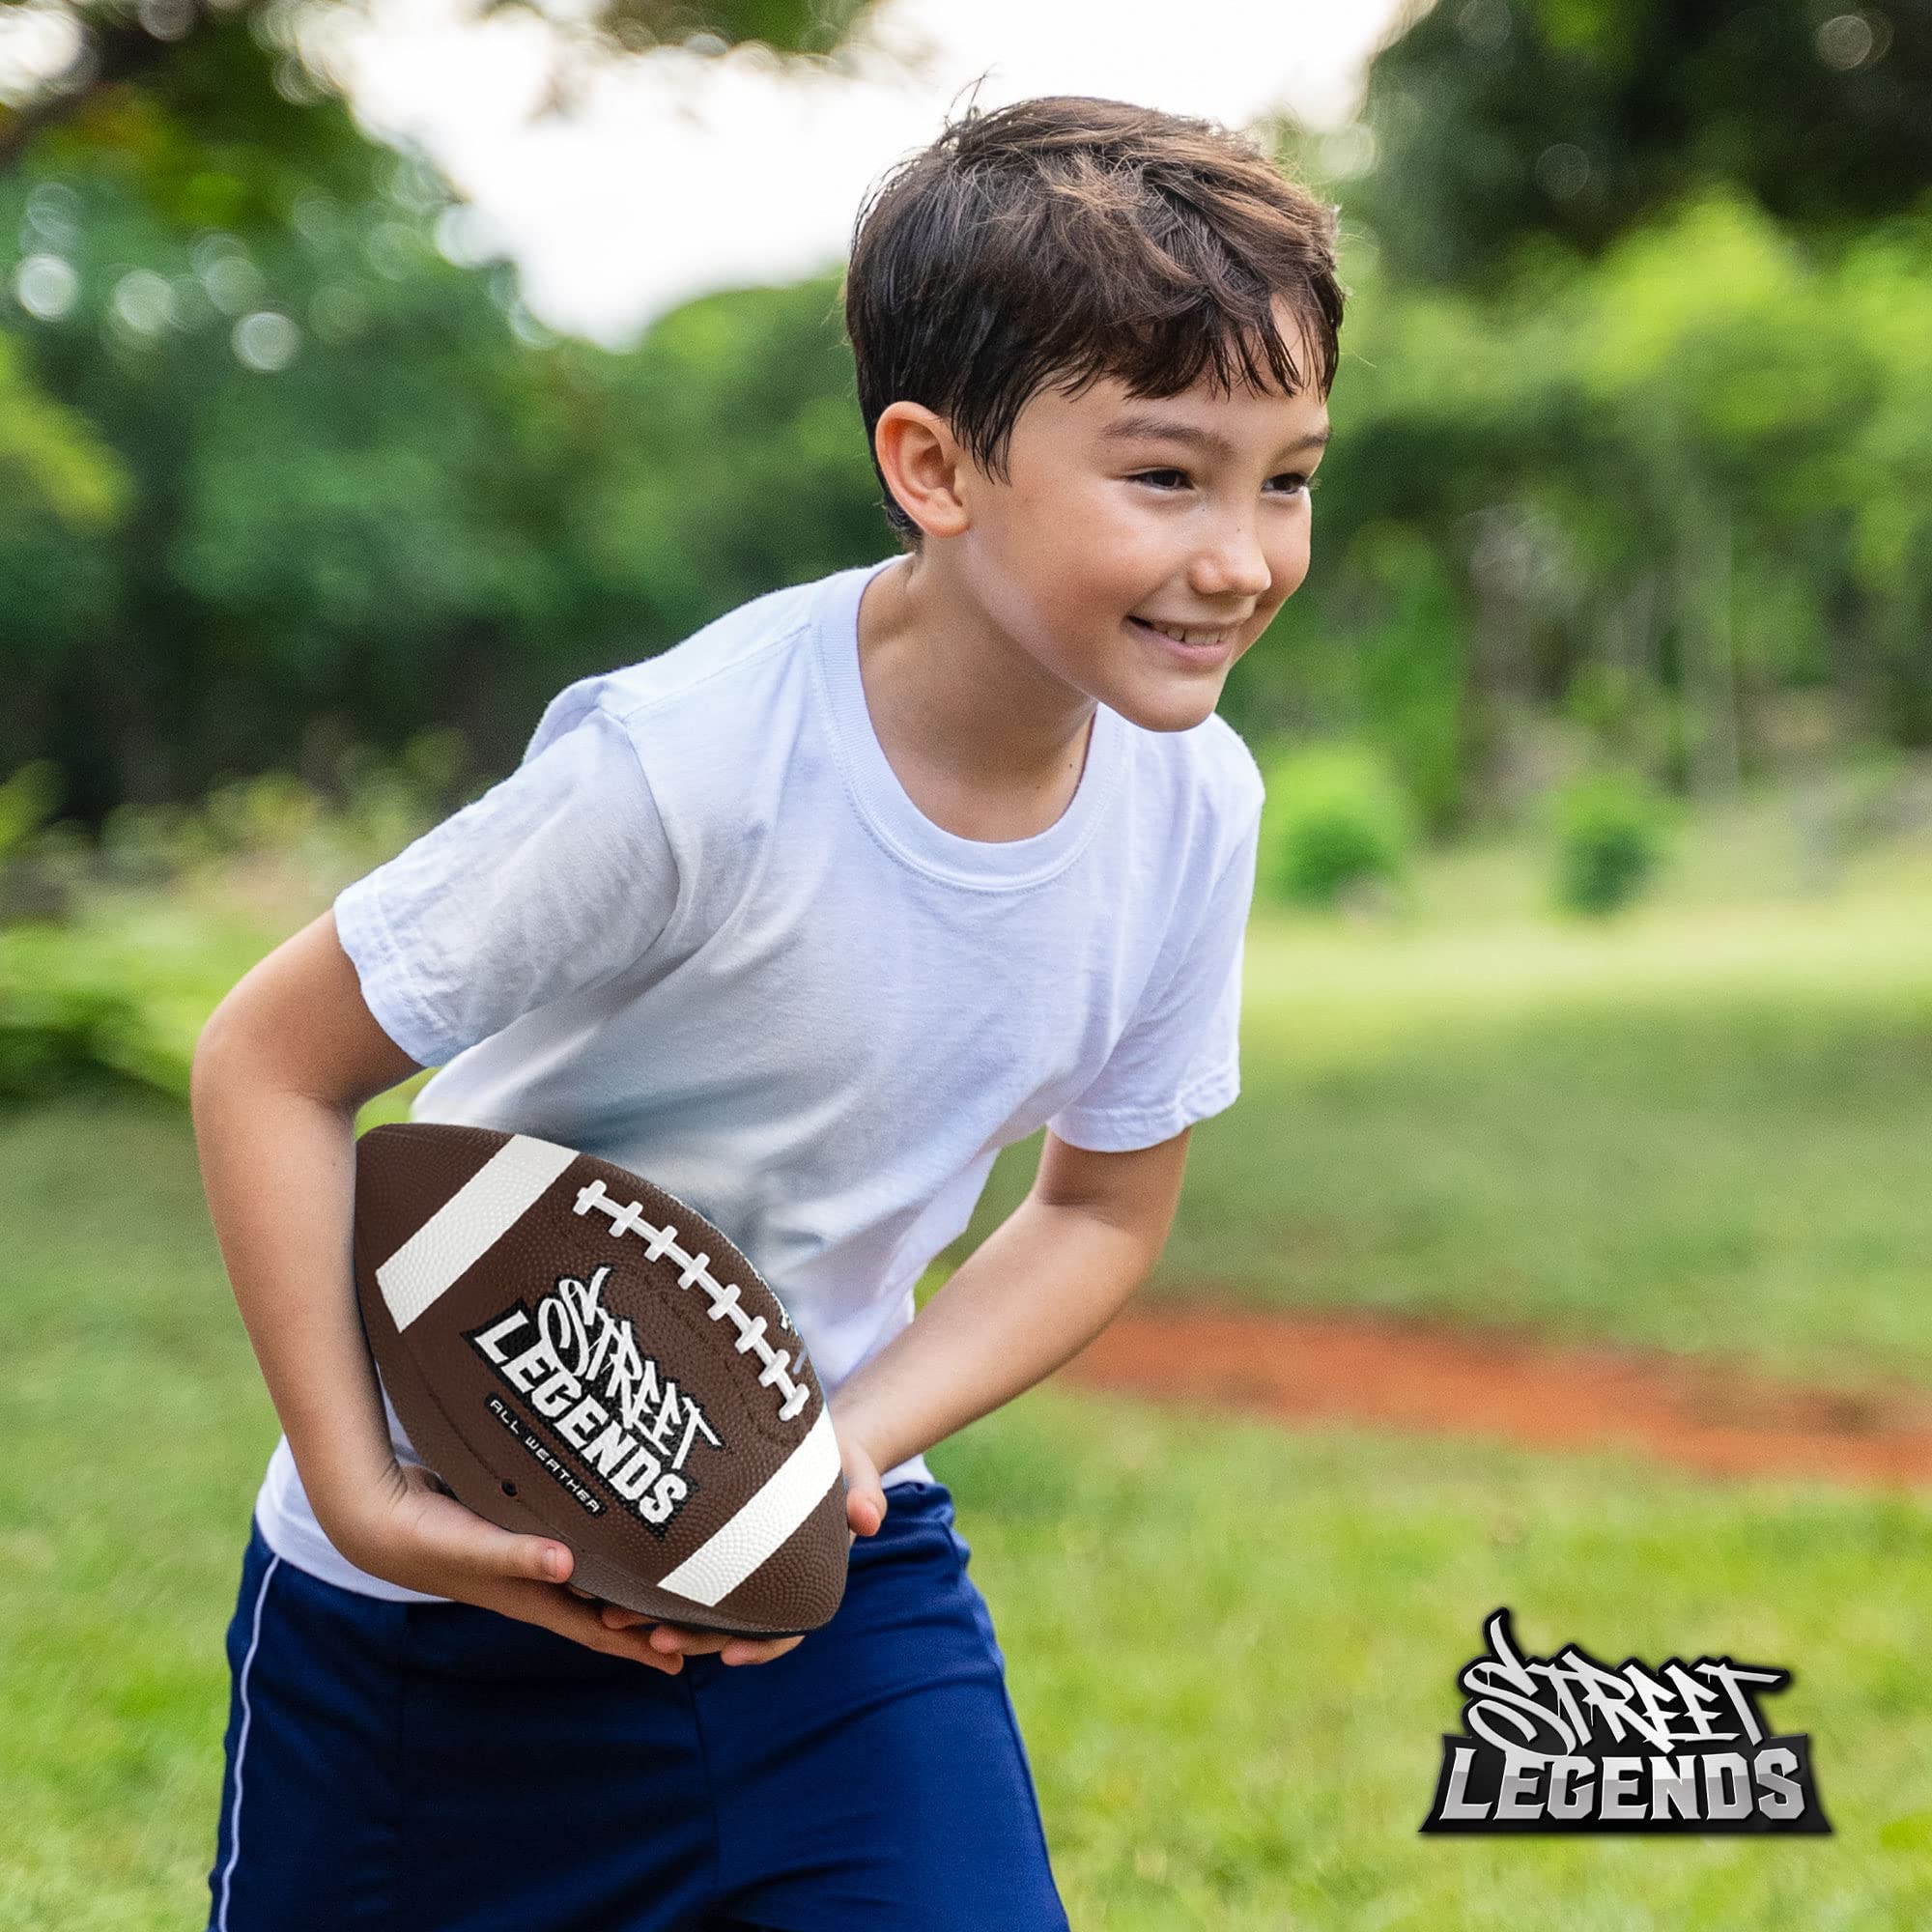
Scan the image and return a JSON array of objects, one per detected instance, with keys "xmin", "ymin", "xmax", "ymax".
[{"xmin": 1047, "ymin": 796, "xmax": 1260, "ymax": 1153}]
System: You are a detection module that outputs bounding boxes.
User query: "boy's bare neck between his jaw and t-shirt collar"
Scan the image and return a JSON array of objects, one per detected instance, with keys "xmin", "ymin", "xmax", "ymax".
[{"xmin": 858, "ymin": 556, "xmax": 1097, "ymax": 844}]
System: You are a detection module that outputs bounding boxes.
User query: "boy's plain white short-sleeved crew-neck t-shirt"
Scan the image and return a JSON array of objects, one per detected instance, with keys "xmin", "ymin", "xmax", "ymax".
[{"xmin": 257, "ymin": 556, "xmax": 1262, "ymax": 1602}]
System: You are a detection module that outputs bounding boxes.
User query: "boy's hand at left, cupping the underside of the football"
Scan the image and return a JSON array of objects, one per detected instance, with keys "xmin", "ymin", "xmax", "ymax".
[{"xmin": 328, "ymin": 1461, "xmax": 684, "ymax": 1677}]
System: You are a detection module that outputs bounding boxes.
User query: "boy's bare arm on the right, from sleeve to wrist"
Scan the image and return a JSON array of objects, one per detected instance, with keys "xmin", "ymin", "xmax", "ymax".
[{"xmin": 831, "ymin": 1128, "xmax": 1192, "ymax": 1470}]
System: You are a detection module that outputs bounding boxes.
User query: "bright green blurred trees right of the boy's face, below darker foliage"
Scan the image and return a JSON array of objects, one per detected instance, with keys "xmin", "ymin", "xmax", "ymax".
[{"xmin": 1260, "ymin": 191, "xmax": 1932, "ymax": 833}]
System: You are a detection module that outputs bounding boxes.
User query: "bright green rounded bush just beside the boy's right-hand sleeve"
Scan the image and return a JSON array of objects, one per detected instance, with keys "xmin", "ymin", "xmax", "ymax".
[{"xmin": 1260, "ymin": 744, "xmax": 1416, "ymax": 906}]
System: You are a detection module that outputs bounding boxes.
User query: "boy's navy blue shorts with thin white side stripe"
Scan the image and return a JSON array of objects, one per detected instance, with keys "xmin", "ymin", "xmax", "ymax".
[{"xmin": 209, "ymin": 1482, "xmax": 1066, "ymax": 1932}]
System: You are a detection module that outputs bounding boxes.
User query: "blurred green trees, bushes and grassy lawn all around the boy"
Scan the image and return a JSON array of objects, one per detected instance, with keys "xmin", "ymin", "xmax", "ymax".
[{"xmin": 0, "ymin": 0, "xmax": 1932, "ymax": 1928}]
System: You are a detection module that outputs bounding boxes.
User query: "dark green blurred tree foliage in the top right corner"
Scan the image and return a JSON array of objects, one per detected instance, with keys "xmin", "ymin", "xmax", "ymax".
[{"xmin": 1349, "ymin": 0, "xmax": 1932, "ymax": 282}]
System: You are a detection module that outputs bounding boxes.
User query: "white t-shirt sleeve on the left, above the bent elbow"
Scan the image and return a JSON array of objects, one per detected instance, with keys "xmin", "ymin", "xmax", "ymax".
[{"xmin": 334, "ymin": 707, "xmax": 678, "ymax": 1066}]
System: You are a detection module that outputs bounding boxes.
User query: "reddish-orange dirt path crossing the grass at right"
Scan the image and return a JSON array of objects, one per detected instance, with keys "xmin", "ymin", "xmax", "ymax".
[{"xmin": 1061, "ymin": 1304, "xmax": 1932, "ymax": 1484}]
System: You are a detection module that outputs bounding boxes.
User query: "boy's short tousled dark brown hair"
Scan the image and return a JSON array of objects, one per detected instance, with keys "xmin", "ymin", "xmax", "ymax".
[{"xmin": 844, "ymin": 95, "xmax": 1345, "ymax": 551}]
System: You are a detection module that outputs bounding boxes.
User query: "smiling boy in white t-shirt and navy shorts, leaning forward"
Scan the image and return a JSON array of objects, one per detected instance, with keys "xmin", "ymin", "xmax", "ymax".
[{"xmin": 193, "ymin": 97, "xmax": 1343, "ymax": 1932}]
